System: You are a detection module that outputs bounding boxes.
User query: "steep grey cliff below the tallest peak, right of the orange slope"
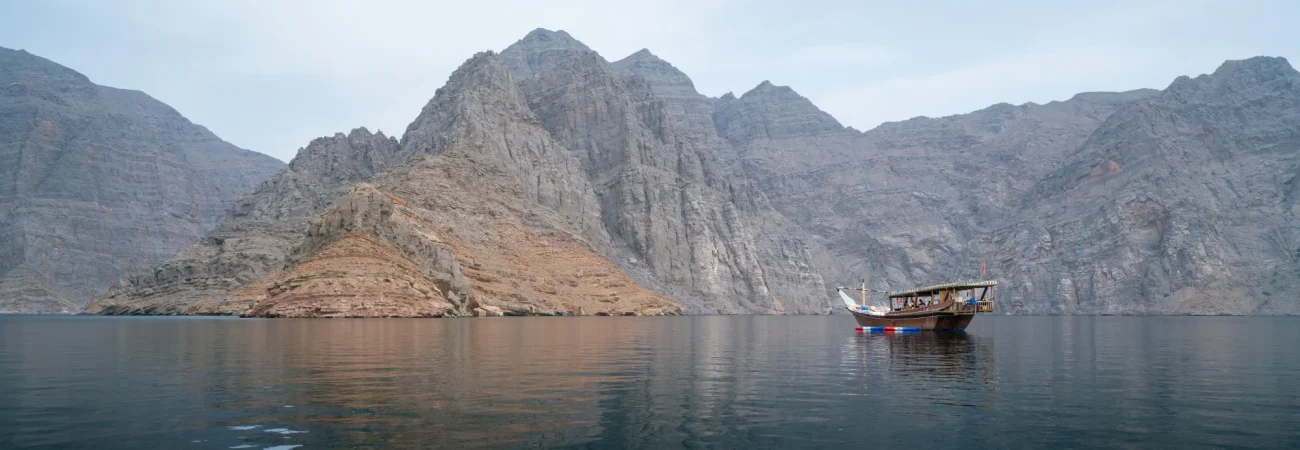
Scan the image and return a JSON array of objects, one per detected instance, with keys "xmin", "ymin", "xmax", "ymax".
[{"xmin": 502, "ymin": 30, "xmax": 829, "ymax": 313}]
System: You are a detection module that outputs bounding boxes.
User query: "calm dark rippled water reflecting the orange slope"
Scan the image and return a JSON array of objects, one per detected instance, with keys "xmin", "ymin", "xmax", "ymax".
[{"xmin": 0, "ymin": 316, "xmax": 1300, "ymax": 450}]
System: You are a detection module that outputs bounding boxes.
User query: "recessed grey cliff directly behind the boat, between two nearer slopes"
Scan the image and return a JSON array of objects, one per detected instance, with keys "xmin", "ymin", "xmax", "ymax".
[{"xmin": 715, "ymin": 82, "xmax": 1154, "ymax": 305}]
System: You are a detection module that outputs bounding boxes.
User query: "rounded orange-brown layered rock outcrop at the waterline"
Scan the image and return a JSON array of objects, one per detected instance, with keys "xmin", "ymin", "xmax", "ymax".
[{"xmin": 237, "ymin": 185, "xmax": 468, "ymax": 317}]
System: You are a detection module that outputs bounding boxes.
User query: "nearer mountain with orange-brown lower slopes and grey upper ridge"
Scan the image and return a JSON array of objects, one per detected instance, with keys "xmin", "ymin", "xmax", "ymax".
[{"xmin": 90, "ymin": 52, "xmax": 680, "ymax": 316}]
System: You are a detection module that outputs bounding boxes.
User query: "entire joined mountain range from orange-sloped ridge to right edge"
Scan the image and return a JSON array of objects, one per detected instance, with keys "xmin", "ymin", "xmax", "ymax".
[{"xmin": 91, "ymin": 30, "xmax": 1300, "ymax": 316}]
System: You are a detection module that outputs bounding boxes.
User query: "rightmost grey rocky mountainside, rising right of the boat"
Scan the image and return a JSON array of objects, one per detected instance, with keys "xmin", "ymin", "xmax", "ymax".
[{"xmin": 985, "ymin": 57, "xmax": 1300, "ymax": 313}]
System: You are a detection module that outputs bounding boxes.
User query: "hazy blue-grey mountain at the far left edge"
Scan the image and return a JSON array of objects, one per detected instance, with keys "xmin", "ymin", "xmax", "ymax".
[{"xmin": 0, "ymin": 48, "xmax": 283, "ymax": 312}]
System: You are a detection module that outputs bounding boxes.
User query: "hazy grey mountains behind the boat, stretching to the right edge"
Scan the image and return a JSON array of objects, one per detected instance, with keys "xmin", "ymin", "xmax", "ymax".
[{"xmin": 715, "ymin": 57, "xmax": 1300, "ymax": 313}]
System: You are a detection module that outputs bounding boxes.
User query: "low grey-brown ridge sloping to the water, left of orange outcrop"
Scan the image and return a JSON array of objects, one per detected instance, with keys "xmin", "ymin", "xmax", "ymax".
[{"xmin": 87, "ymin": 129, "xmax": 398, "ymax": 315}]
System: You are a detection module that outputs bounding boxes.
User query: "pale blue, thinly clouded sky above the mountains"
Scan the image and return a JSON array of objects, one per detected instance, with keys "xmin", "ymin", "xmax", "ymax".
[{"xmin": 0, "ymin": 0, "xmax": 1300, "ymax": 161}]
